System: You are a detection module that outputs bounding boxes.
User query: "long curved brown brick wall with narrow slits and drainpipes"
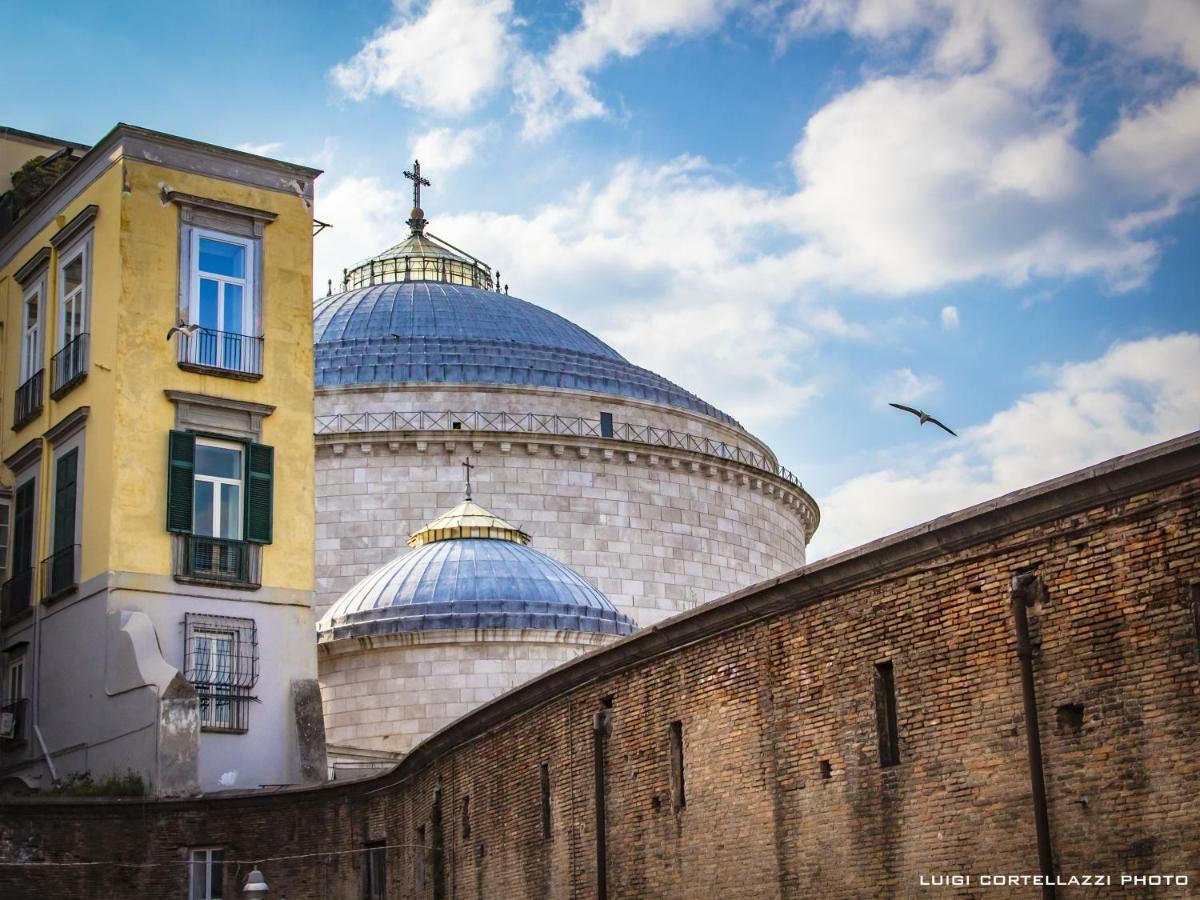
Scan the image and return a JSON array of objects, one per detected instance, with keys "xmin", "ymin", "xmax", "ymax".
[{"xmin": 0, "ymin": 434, "xmax": 1200, "ymax": 899}]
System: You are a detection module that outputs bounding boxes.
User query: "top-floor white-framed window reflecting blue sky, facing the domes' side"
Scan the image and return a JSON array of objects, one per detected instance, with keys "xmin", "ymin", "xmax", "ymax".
[{"xmin": 180, "ymin": 228, "xmax": 263, "ymax": 376}]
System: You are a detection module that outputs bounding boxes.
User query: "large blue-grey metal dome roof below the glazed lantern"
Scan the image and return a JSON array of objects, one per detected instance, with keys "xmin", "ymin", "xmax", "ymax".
[{"xmin": 313, "ymin": 281, "xmax": 736, "ymax": 425}]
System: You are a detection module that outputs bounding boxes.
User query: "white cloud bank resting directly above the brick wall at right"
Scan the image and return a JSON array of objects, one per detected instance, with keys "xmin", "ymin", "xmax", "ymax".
[{"xmin": 810, "ymin": 334, "xmax": 1200, "ymax": 559}]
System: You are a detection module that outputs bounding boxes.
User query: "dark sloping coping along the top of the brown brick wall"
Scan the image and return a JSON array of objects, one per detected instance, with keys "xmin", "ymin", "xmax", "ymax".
[{"xmin": 6, "ymin": 432, "xmax": 1200, "ymax": 806}]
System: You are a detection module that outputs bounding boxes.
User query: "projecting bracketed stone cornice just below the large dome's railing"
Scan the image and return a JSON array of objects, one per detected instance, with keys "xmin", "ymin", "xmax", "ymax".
[{"xmin": 317, "ymin": 430, "xmax": 821, "ymax": 544}]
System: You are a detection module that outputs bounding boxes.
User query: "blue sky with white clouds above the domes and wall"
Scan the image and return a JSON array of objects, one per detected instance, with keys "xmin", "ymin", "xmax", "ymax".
[{"xmin": 0, "ymin": 0, "xmax": 1200, "ymax": 557}]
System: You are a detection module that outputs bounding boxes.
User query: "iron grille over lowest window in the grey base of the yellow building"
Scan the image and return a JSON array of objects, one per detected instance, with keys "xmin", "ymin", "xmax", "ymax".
[{"xmin": 184, "ymin": 613, "xmax": 258, "ymax": 734}]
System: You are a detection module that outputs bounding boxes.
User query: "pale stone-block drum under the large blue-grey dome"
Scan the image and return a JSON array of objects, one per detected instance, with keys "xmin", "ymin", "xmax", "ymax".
[{"xmin": 317, "ymin": 388, "xmax": 816, "ymax": 625}]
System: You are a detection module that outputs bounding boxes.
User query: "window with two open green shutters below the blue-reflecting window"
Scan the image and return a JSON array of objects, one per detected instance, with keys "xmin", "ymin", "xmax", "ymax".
[{"xmin": 167, "ymin": 431, "xmax": 275, "ymax": 586}]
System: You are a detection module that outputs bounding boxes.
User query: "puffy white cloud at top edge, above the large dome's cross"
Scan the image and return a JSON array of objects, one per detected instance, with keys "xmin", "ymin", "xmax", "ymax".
[{"xmin": 330, "ymin": 0, "xmax": 512, "ymax": 114}]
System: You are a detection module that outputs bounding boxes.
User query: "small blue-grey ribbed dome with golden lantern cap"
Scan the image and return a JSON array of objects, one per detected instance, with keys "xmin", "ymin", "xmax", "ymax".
[{"xmin": 317, "ymin": 500, "xmax": 636, "ymax": 642}]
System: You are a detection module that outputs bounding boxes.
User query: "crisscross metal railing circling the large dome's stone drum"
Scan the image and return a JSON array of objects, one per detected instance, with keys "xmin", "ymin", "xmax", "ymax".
[{"xmin": 316, "ymin": 410, "xmax": 803, "ymax": 488}]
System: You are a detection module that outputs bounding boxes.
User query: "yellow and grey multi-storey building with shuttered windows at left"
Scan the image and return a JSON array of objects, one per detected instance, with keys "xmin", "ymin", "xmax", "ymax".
[{"xmin": 0, "ymin": 125, "xmax": 323, "ymax": 794}]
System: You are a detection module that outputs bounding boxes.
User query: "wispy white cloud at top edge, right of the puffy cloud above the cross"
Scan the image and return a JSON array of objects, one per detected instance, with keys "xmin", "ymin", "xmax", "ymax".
[{"xmin": 512, "ymin": 0, "xmax": 736, "ymax": 139}]
